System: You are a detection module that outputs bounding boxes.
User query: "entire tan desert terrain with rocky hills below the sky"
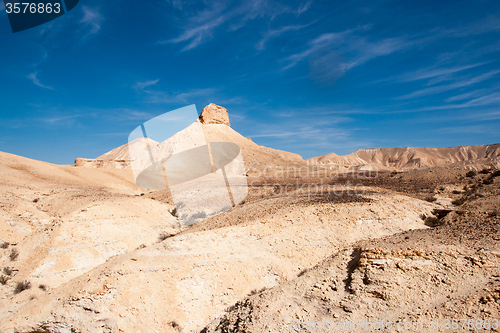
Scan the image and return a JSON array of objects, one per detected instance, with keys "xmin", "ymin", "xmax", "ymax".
[{"xmin": 0, "ymin": 104, "xmax": 500, "ymax": 333}]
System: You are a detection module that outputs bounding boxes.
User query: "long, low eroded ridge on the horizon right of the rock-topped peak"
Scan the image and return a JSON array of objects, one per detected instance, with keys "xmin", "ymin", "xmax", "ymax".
[{"xmin": 307, "ymin": 143, "xmax": 500, "ymax": 170}]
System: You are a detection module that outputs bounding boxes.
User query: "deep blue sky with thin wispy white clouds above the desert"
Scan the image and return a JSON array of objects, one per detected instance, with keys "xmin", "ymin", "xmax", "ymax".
[{"xmin": 0, "ymin": 0, "xmax": 500, "ymax": 164}]
